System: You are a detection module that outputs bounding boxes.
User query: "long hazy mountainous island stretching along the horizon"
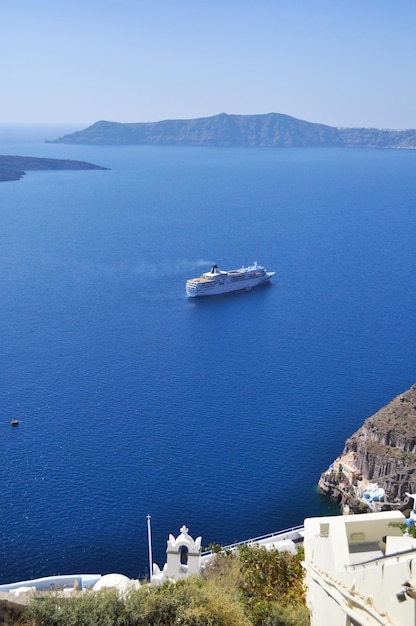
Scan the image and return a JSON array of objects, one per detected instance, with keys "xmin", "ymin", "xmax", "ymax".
[{"xmin": 47, "ymin": 113, "xmax": 416, "ymax": 149}]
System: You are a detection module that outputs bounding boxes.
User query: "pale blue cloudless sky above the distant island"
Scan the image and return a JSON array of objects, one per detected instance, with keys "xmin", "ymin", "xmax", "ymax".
[{"xmin": 0, "ymin": 0, "xmax": 416, "ymax": 128}]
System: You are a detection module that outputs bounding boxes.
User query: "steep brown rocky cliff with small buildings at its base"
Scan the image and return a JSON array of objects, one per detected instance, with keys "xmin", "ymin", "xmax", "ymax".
[{"xmin": 319, "ymin": 385, "xmax": 416, "ymax": 513}]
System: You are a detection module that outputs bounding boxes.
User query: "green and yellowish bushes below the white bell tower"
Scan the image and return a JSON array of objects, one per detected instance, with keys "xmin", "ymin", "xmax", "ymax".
[{"xmin": 14, "ymin": 547, "xmax": 309, "ymax": 626}]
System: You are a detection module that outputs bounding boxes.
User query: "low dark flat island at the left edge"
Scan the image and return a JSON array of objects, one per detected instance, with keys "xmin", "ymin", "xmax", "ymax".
[{"xmin": 0, "ymin": 155, "xmax": 108, "ymax": 182}]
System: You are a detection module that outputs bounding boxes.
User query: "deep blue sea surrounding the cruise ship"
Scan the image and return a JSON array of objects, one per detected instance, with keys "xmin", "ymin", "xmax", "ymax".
[{"xmin": 0, "ymin": 127, "xmax": 416, "ymax": 583}]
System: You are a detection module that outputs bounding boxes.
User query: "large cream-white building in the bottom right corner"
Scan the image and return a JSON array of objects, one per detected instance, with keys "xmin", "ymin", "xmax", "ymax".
[{"xmin": 304, "ymin": 511, "xmax": 416, "ymax": 626}]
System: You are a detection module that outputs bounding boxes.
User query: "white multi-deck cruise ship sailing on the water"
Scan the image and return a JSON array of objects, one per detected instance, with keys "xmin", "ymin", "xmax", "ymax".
[{"xmin": 186, "ymin": 261, "xmax": 276, "ymax": 298}]
